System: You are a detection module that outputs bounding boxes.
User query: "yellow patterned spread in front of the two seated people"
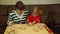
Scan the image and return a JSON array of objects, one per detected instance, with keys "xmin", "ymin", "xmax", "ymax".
[{"xmin": 4, "ymin": 23, "xmax": 49, "ymax": 34}]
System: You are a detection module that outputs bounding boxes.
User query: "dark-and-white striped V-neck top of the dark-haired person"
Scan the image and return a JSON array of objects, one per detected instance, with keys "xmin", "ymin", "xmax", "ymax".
[{"xmin": 8, "ymin": 10, "xmax": 29, "ymax": 24}]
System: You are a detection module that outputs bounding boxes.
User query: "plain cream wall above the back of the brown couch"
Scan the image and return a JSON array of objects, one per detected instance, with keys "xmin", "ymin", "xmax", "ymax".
[{"xmin": 0, "ymin": 0, "xmax": 60, "ymax": 5}]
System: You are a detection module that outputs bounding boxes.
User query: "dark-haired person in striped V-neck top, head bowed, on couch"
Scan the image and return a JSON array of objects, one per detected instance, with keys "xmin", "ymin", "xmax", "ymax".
[{"xmin": 8, "ymin": 1, "xmax": 28, "ymax": 25}]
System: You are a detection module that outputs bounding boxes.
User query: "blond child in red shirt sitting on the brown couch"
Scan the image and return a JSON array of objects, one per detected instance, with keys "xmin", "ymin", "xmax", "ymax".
[{"xmin": 27, "ymin": 7, "xmax": 40, "ymax": 25}]
